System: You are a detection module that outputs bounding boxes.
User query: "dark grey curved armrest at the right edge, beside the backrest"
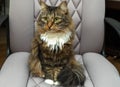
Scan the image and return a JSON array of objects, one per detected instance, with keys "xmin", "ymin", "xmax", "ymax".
[{"xmin": 105, "ymin": 17, "xmax": 120, "ymax": 37}]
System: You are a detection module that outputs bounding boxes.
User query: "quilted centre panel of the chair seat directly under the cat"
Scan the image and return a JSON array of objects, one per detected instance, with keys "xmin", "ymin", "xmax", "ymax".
[{"xmin": 27, "ymin": 55, "xmax": 93, "ymax": 87}]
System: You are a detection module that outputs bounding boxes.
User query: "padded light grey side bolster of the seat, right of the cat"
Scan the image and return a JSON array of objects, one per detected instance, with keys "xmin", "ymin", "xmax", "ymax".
[{"xmin": 83, "ymin": 53, "xmax": 120, "ymax": 87}]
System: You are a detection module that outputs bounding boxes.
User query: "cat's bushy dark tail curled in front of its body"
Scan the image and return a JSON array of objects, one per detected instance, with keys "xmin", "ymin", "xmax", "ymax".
[{"xmin": 57, "ymin": 66, "xmax": 86, "ymax": 87}]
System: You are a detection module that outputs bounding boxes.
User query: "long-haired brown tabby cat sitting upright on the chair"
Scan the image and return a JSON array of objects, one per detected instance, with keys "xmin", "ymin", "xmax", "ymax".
[{"xmin": 29, "ymin": 0, "xmax": 85, "ymax": 87}]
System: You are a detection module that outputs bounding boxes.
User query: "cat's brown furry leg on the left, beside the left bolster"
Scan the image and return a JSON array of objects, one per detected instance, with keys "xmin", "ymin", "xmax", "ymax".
[{"xmin": 29, "ymin": 39, "xmax": 45, "ymax": 77}]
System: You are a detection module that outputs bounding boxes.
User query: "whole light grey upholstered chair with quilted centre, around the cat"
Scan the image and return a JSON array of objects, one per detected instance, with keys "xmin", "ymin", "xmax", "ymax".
[{"xmin": 0, "ymin": 0, "xmax": 120, "ymax": 87}]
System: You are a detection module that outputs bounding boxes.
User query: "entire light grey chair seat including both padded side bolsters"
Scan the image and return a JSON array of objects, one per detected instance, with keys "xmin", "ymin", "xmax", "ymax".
[{"xmin": 0, "ymin": 52, "xmax": 120, "ymax": 87}]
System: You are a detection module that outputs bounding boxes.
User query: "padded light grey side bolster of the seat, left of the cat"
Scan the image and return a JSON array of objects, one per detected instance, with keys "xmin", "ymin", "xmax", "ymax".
[{"xmin": 0, "ymin": 52, "xmax": 29, "ymax": 87}]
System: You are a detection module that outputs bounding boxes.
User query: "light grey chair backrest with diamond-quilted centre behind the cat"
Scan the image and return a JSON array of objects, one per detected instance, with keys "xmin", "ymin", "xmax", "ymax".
[{"xmin": 9, "ymin": 0, "xmax": 105, "ymax": 54}]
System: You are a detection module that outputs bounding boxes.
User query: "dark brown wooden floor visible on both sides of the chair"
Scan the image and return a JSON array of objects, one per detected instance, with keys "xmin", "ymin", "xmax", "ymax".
[{"xmin": 0, "ymin": 27, "xmax": 120, "ymax": 72}]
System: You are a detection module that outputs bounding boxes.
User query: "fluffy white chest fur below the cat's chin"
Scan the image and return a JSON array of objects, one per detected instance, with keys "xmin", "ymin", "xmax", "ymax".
[{"xmin": 40, "ymin": 32, "xmax": 71, "ymax": 51}]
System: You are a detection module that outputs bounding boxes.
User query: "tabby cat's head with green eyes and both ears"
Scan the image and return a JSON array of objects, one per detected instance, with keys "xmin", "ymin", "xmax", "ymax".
[{"xmin": 37, "ymin": 0, "xmax": 74, "ymax": 34}]
